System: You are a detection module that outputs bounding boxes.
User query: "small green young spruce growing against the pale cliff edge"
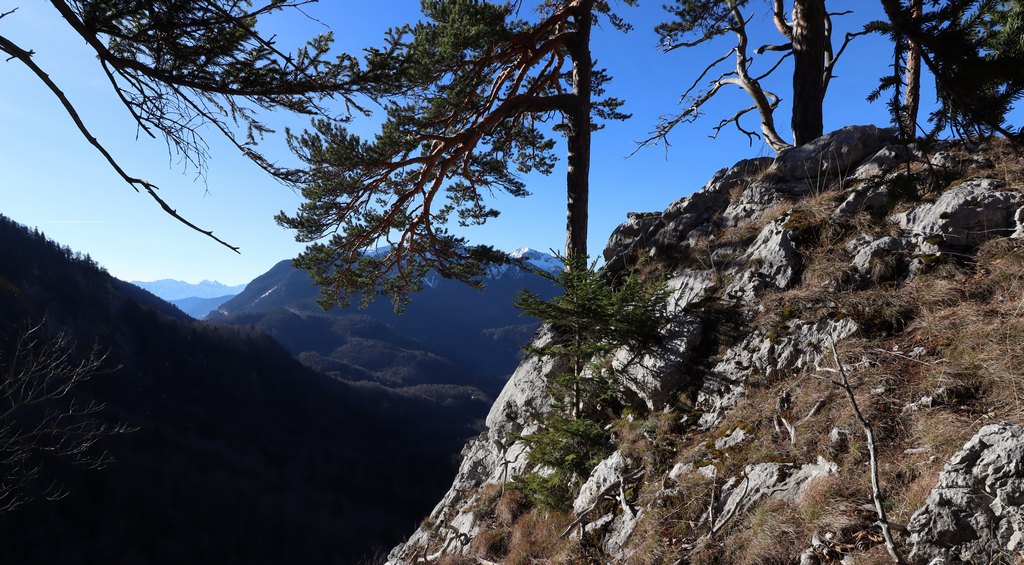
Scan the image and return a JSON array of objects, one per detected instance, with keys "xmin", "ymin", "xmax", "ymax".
[{"xmin": 514, "ymin": 257, "xmax": 668, "ymax": 510}]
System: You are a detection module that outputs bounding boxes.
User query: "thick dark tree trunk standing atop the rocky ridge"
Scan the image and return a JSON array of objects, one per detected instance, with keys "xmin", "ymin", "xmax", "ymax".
[{"xmin": 793, "ymin": 0, "xmax": 825, "ymax": 145}]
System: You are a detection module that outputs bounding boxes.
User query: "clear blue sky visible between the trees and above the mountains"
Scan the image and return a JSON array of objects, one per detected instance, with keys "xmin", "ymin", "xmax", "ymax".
[{"xmin": 0, "ymin": 0, "xmax": 933, "ymax": 284}]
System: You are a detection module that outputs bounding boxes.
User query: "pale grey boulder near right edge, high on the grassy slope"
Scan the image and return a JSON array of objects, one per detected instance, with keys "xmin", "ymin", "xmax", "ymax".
[{"xmin": 895, "ymin": 178, "xmax": 1024, "ymax": 251}]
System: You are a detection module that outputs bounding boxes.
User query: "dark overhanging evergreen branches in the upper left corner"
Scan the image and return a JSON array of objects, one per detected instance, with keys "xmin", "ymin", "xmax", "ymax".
[{"xmin": 0, "ymin": 0, "xmax": 358, "ymax": 251}]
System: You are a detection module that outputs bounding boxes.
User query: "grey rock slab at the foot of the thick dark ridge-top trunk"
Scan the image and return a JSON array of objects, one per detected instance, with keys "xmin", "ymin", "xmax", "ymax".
[{"xmin": 771, "ymin": 126, "xmax": 896, "ymax": 179}]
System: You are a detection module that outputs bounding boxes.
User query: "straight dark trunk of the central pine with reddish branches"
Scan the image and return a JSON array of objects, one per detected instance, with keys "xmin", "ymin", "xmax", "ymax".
[{"xmin": 565, "ymin": 0, "xmax": 594, "ymax": 259}]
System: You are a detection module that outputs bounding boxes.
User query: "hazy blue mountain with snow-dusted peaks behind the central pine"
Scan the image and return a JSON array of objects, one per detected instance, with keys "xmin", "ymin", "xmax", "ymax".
[{"xmin": 207, "ymin": 248, "xmax": 561, "ymax": 395}]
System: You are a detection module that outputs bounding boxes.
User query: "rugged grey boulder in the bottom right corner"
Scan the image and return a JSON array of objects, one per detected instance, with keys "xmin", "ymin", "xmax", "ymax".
[{"xmin": 907, "ymin": 424, "xmax": 1024, "ymax": 564}]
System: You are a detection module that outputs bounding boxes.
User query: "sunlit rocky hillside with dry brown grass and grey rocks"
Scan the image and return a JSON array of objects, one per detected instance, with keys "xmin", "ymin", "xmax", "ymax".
[{"xmin": 389, "ymin": 126, "xmax": 1024, "ymax": 564}]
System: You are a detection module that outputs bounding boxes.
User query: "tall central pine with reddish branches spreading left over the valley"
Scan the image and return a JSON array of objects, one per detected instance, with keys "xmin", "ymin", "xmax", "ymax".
[{"xmin": 278, "ymin": 0, "xmax": 635, "ymax": 305}]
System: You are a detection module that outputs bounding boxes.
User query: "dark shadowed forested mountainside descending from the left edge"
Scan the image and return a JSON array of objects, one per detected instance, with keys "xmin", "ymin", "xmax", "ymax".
[{"xmin": 0, "ymin": 216, "xmax": 488, "ymax": 565}]
